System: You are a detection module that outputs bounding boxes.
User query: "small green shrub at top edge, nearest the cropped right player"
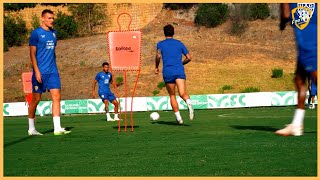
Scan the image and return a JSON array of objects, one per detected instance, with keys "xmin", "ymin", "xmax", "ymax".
[{"xmin": 248, "ymin": 3, "xmax": 270, "ymax": 20}]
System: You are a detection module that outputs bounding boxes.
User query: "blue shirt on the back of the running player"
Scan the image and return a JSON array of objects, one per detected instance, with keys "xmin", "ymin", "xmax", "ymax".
[{"xmin": 157, "ymin": 38, "xmax": 189, "ymax": 76}]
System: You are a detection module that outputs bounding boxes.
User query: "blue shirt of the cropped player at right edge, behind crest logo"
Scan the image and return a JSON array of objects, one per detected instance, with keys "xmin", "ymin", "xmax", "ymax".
[{"xmin": 290, "ymin": 3, "xmax": 318, "ymax": 62}]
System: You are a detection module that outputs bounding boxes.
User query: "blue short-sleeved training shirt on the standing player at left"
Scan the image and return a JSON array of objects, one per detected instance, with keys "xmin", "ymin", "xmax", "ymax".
[{"xmin": 29, "ymin": 27, "xmax": 58, "ymax": 74}]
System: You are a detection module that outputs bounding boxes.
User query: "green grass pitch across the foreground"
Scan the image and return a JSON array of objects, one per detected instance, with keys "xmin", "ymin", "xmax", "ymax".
[{"xmin": 3, "ymin": 107, "xmax": 317, "ymax": 176}]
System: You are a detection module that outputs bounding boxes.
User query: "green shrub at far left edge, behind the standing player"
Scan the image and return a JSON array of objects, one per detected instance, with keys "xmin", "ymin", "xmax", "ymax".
[{"xmin": 3, "ymin": 15, "xmax": 28, "ymax": 47}]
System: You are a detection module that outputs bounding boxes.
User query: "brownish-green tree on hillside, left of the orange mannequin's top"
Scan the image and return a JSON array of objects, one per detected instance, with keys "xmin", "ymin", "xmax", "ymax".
[{"xmin": 69, "ymin": 3, "xmax": 107, "ymax": 35}]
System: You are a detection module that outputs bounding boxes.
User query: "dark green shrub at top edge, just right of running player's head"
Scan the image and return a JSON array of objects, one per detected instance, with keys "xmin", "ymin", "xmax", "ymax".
[{"xmin": 194, "ymin": 3, "xmax": 228, "ymax": 27}]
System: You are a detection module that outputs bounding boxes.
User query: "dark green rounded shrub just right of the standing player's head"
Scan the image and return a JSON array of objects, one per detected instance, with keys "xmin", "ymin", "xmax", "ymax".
[{"xmin": 54, "ymin": 11, "xmax": 78, "ymax": 39}]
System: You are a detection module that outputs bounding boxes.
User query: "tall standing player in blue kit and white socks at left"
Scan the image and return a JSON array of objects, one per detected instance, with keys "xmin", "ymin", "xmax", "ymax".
[{"xmin": 28, "ymin": 9, "xmax": 70, "ymax": 135}]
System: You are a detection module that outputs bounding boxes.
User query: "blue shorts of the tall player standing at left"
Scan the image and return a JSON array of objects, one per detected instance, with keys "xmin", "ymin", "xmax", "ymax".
[{"xmin": 32, "ymin": 73, "xmax": 61, "ymax": 93}]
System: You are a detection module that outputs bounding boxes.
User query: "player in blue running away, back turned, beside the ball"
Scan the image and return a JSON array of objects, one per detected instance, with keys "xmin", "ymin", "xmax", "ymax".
[{"xmin": 155, "ymin": 24, "xmax": 194, "ymax": 124}]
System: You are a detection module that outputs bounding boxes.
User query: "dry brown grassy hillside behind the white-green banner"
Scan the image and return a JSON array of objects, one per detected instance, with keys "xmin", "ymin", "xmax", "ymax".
[{"xmin": 4, "ymin": 9, "xmax": 296, "ymax": 102}]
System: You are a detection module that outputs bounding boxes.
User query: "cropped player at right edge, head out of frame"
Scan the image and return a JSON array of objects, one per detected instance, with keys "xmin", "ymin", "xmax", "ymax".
[{"xmin": 276, "ymin": 3, "xmax": 318, "ymax": 136}]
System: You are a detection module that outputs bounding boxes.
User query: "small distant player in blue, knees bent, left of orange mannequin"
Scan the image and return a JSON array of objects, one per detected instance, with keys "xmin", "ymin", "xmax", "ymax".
[{"xmin": 92, "ymin": 62, "xmax": 120, "ymax": 121}]
